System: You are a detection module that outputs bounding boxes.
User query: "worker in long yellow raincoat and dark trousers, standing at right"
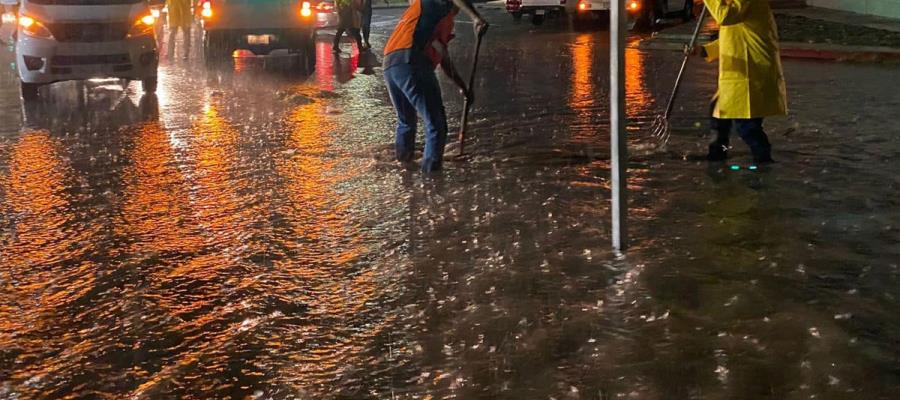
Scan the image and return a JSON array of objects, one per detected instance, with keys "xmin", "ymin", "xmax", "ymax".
[{"xmin": 703, "ymin": 0, "xmax": 787, "ymax": 163}]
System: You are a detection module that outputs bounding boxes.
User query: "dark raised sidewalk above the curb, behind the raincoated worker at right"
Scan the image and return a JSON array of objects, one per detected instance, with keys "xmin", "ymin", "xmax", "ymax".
[{"xmin": 638, "ymin": 7, "xmax": 900, "ymax": 61}]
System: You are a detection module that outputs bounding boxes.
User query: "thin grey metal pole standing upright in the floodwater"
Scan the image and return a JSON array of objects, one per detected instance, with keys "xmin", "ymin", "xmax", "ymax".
[{"xmin": 609, "ymin": 0, "xmax": 628, "ymax": 251}]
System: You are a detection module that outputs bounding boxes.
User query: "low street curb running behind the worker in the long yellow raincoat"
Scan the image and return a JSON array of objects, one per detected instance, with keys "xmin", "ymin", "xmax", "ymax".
[{"xmin": 632, "ymin": 38, "xmax": 900, "ymax": 62}]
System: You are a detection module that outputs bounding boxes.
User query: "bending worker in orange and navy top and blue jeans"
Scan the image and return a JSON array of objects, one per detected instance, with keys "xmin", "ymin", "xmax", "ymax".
[{"xmin": 383, "ymin": 0, "xmax": 488, "ymax": 172}]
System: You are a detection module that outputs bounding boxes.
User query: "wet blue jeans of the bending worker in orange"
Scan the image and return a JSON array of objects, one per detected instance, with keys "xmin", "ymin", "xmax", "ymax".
[{"xmin": 384, "ymin": 63, "xmax": 447, "ymax": 172}]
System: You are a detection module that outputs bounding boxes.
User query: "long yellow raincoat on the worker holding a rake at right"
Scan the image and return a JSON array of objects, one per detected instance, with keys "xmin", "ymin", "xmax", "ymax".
[{"xmin": 703, "ymin": 0, "xmax": 787, "ymax": 119}]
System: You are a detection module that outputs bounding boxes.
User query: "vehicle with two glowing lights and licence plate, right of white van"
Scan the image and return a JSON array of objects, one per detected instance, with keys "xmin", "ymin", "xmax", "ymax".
[{"xmin": 199, "ymin": 0, "xmax": 319, "ymax": 73}]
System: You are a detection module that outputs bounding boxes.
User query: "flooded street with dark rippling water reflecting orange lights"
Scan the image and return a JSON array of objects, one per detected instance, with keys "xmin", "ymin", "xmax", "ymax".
[{"xmin": 0, "ymin": 10, "xmax": 900, "ymax": 400}]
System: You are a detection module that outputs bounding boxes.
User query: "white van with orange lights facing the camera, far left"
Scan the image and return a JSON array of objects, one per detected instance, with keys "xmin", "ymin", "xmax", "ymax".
[{"xmin": 16, "ymin": 0, "xmax": 159, "ymax": 100}]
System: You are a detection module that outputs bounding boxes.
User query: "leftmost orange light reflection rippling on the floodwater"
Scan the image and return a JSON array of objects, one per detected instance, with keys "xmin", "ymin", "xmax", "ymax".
[{"xmin": 0, "ymin": 131, "xmax": 103, "ymax": 390}]
